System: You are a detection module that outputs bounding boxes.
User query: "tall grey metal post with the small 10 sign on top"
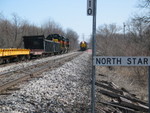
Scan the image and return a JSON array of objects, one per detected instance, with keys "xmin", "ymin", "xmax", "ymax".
[{"xmin": 87, "ymin": 0, "xmax": 97, "ymax": 113}]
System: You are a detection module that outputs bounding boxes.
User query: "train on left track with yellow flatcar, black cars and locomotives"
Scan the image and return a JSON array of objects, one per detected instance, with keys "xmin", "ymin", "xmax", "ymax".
[{"xmin": 0, "ymin": 34, "xmax": 70, "ymax": 64}]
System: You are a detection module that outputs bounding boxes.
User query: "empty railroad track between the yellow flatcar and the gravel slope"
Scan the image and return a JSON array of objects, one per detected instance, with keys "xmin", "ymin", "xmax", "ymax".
[{"xmin": 0, "ymin": 52, "xmax": 82, "ymax": 94}]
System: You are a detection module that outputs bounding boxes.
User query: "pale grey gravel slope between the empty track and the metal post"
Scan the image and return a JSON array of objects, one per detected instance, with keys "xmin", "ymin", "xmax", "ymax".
[{"xmin": 0, "ymin": 52, "xmax": 91, "ymax": 113}]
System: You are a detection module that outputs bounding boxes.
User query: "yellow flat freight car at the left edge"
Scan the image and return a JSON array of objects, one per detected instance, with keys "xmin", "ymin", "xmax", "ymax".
[{"xmin": 0, "ymin": 48, "xmax": 30, "ymax": 64}]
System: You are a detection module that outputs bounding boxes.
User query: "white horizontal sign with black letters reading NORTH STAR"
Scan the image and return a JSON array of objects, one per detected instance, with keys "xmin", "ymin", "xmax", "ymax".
[{"xmin": 94, "ymin": 56, "xmax": 150, "ymax": 66}]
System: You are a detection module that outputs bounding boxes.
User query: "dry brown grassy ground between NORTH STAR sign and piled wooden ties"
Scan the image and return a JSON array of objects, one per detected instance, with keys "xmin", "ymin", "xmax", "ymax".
[{"xmin": 96, "ymin": 67, "xmax": 148, "ymax": 102}]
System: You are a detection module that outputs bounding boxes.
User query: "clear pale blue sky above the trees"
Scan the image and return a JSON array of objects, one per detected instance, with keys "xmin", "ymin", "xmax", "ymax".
[{"xmin": 0, "ymin": 0, "xmax": 139, "ymax": 41}]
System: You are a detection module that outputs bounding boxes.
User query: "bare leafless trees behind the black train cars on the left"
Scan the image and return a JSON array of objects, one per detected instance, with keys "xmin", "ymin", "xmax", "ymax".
[{"xmin": 0, "ymin": 13, "xmax": 79, "ymax": 50}]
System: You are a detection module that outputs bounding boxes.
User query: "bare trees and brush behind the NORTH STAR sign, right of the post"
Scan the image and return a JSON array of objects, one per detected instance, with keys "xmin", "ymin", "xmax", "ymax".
[{"xmin": 96, "ymin": 0, "xmax": 150, "ymax": 56}]
